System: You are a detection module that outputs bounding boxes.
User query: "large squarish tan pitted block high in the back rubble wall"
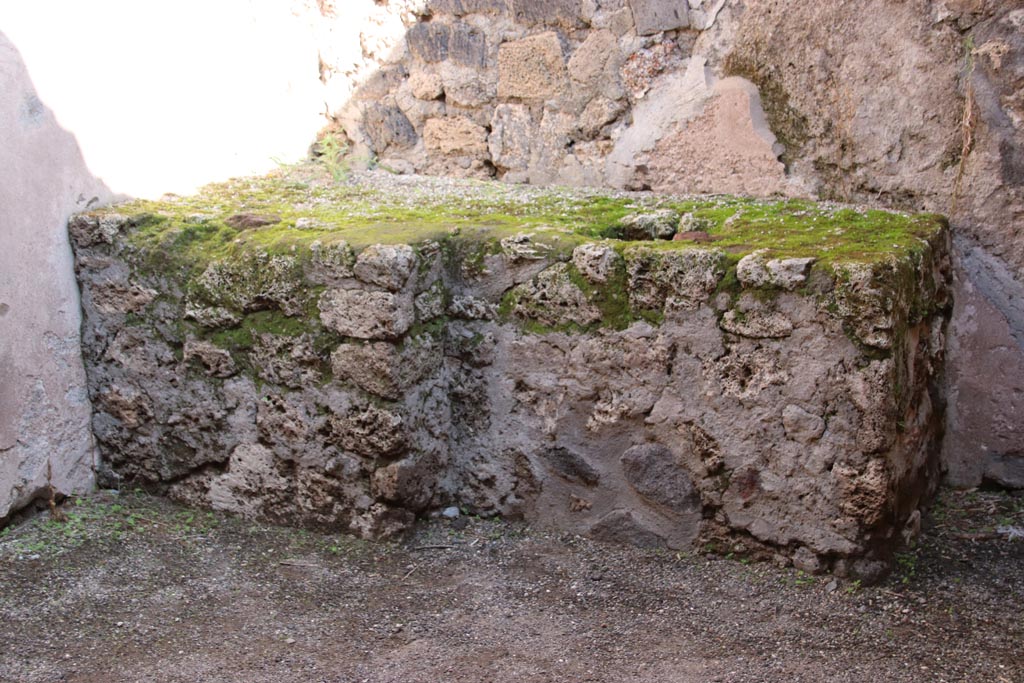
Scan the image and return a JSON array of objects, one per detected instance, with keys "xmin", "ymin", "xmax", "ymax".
[{"xmin": 498, "ymin": 31, "xmax": 568, "ymax": 100}]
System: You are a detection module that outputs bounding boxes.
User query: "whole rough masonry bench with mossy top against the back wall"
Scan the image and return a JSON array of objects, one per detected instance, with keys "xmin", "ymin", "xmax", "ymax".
[{"xmin": 70, "ymin": 168, "xmax": 950, "ymax": 577}]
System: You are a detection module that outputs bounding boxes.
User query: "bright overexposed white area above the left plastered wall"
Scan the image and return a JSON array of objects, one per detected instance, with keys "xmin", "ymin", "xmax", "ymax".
[{"xmin": 0, "ymin": 0, "xmax": 326, "ymax": 197}]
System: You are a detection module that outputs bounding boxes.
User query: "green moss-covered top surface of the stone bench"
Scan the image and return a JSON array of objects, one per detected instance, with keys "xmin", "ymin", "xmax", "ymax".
[{"xmin": 83, "ymin": 165, "xmax": 946, "ymax": 265}]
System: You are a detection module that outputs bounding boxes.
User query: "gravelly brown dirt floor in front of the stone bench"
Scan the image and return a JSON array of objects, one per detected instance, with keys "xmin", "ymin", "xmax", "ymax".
[{"xmin": 0, "ymin": 492, "xmax": 1024, "ymax": 683}]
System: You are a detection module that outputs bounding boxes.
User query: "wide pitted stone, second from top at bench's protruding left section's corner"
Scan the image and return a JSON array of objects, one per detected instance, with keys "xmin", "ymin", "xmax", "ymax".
[{"xmin": 318, "ymin": 290, "xmax": 415, "ymax": 339}]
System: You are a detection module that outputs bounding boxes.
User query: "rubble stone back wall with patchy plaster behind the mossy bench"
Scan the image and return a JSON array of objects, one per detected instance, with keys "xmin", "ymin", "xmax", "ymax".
[{"xmin": 319, "ymin": 0, "xmax": 1024, "ymax": 486}]
